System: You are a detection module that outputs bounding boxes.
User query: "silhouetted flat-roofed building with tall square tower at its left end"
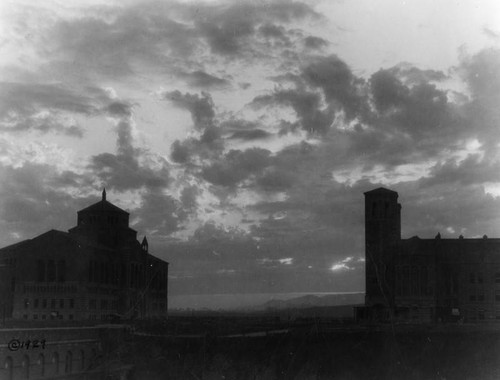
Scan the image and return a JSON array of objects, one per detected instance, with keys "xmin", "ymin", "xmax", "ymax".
[{"xmin": 358, "ymin": 188, "xmax": 500, "ymax": 323}]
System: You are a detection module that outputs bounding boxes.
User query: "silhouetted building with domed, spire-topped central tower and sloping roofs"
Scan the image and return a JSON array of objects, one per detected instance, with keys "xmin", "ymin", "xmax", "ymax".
[{"xmin": 0, "ymin": 190, "xmax": 168, "ymax": 321}]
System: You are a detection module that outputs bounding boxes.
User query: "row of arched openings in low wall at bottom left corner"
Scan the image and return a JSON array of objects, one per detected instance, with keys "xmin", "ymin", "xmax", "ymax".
[{"xmin": 2, "ymin": 348, "xmax": 97, "ymax": 380}]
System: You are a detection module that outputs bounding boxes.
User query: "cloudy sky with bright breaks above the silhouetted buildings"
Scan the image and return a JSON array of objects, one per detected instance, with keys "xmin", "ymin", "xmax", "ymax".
[{"xmin": 0, "ymin": 0, "xmax": 500, "ymax": 302}]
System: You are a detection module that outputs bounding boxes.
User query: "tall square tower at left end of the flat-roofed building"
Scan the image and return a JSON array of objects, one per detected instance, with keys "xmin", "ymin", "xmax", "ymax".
[{"xmin": 365, "ymin": 187, "xmax": 401, "ymax": 317}]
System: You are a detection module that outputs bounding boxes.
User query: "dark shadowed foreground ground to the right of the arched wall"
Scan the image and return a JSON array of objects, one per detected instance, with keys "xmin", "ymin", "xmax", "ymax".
[{"xmin": 110, "ymin": 324, "xmax": 500, "ymax": 380}]
